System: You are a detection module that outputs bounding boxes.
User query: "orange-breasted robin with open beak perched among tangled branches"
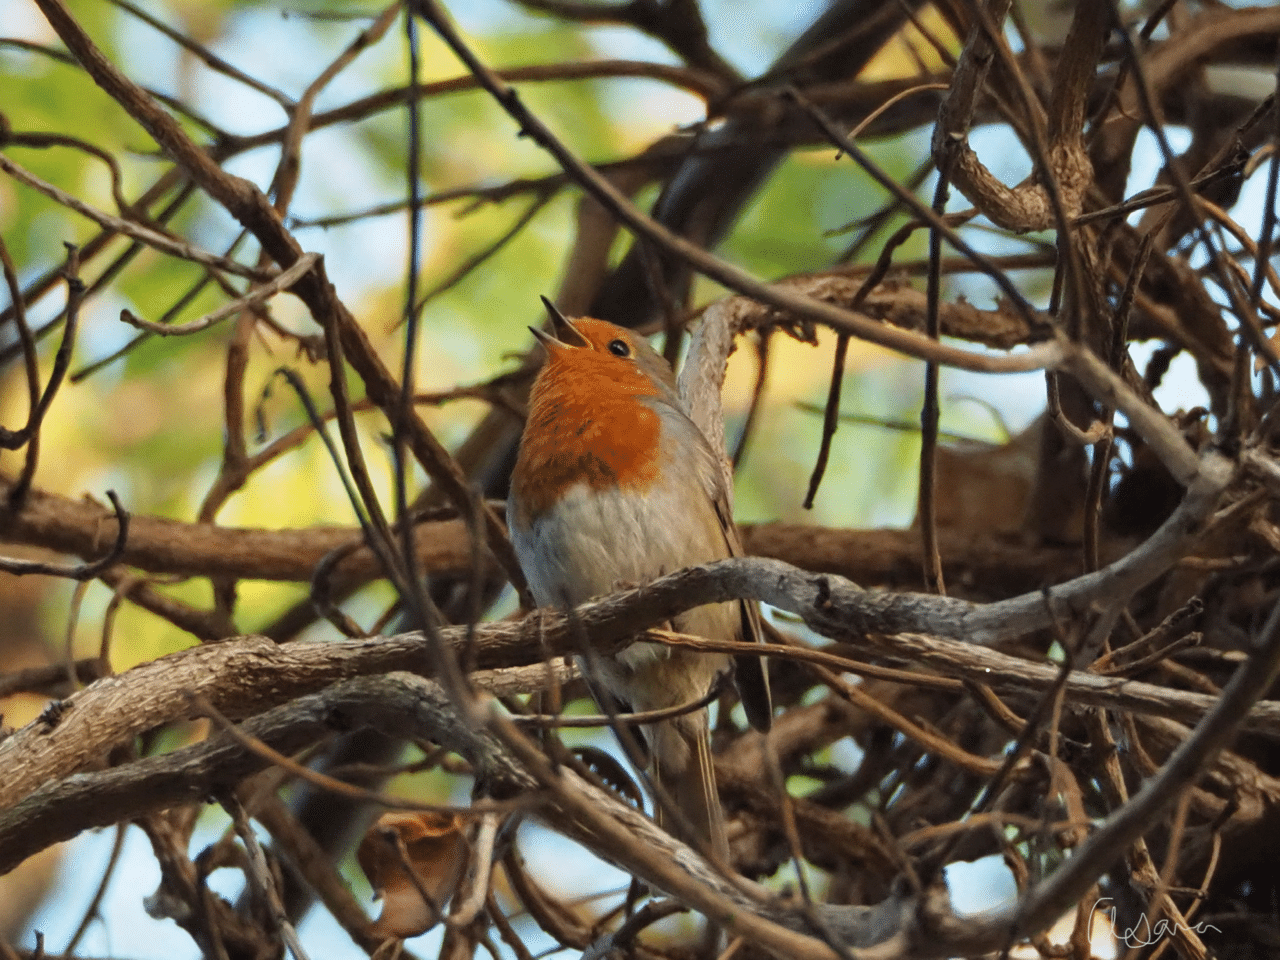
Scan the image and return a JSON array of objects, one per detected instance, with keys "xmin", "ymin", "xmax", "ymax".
[{"xmin": 507, "ymin": 297, "xmax": 772, "ymax": 864}]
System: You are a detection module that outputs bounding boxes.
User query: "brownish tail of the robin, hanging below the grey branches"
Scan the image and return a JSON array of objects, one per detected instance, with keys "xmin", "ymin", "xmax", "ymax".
[{"xmin": 650, "ymin": 710, "xmax": 728, "ymax": 863}]
